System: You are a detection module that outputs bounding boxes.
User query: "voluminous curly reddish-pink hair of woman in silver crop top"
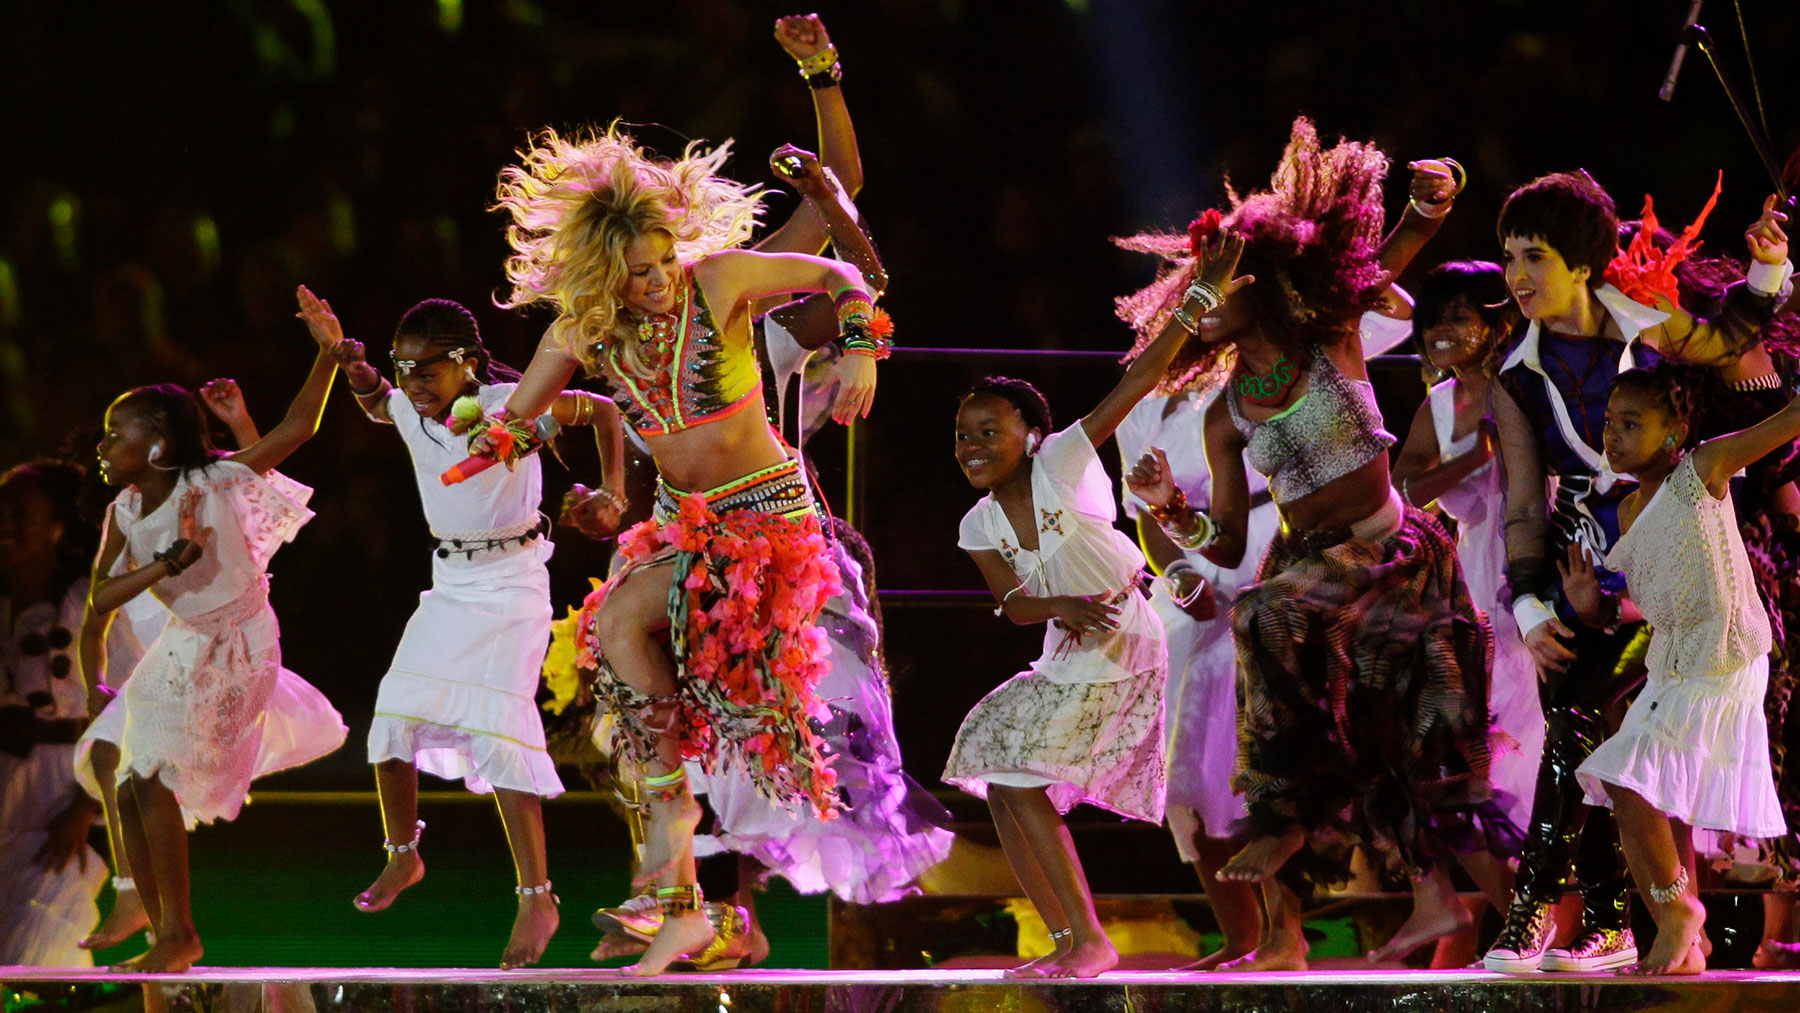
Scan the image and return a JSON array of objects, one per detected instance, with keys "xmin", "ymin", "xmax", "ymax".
[{"xmin": 1112, "ymin": 117, "xmax": 1390, "ymax": 392}]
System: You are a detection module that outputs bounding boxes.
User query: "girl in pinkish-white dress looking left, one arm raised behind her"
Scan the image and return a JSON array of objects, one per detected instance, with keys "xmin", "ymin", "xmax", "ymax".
[{"xmin": 90, "ymin": 309, "xmax": 337, "ymax": 972}]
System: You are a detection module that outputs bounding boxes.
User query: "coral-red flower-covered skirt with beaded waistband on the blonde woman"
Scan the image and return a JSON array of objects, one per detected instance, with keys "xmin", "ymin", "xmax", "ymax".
[{"xmin": 578, "ymin": 461, "xmax": 839, "ymax": 817}]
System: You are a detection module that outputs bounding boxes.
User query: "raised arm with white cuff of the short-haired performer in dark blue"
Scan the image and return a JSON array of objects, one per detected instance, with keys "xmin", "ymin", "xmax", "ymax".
[{"xmin": 1640, "ymin": 194, "xmax": 1791, "ymax": 365}]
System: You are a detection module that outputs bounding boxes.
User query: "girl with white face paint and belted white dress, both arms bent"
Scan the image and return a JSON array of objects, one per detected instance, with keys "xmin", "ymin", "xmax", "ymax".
[{"xmin": 301, "ymin": 288, "xmax": 625, "ymax": 968}]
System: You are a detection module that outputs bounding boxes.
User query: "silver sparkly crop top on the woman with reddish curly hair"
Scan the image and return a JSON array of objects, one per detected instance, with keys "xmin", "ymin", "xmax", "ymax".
[{"xmin": 1226, "ymin": 347, "xmax": 1397, "ymax": 502}]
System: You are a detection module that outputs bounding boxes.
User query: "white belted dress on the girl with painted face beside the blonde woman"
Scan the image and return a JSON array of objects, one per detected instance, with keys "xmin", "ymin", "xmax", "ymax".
[{"xmin": 369, "ymin": 383, "xmax": 563, "ymax": 797}]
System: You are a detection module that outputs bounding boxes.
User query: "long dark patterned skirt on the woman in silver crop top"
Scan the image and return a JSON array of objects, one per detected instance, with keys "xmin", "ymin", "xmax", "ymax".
[{"xmin": 1231, "ymin": 506, "xmax": 1519, "ymax": 894}]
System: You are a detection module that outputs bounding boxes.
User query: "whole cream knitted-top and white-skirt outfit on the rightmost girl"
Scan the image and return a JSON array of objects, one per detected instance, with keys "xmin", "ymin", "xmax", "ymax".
[{"xmin": 1575, "ymin": 455, "xmax": 1787, "ymax": 838}]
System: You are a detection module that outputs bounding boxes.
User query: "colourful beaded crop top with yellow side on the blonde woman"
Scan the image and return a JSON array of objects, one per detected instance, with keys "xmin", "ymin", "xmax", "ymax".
[{"xmin": 594, "ymin": 268, "xmax": 763, "ymax": 435}]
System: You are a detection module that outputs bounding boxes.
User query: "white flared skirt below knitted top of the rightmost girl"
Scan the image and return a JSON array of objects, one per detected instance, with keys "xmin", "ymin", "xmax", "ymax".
[{"xmin": 1575, "ymin": 655, "xmax": 1787, "ymax": 838}]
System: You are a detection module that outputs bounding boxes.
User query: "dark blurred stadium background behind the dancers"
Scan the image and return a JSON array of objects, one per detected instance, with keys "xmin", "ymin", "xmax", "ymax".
[{"xmin": 0, "ymin": 0, "xmax": 1800, "ymax": 786}]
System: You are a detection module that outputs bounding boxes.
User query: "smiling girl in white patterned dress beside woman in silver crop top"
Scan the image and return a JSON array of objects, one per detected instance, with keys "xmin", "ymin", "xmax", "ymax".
[{"xmin": 943, "ymin": 234, "xmax": 1247, "ymax": 977}]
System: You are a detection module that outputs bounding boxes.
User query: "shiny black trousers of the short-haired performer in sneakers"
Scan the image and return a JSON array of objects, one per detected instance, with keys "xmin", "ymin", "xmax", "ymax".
[{"xmin": 1514, "ymin": 623, "xmax": 1643, "ymax": 928}]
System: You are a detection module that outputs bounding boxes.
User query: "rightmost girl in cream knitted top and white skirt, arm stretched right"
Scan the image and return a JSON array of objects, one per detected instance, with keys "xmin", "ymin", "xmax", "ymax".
[{"xmin": 1559, "ymin": 369, "xmax": 1800, "ymax": 975}]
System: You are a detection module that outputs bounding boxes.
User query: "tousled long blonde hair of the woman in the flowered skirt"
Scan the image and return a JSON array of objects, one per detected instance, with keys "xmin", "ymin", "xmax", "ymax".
[{"xmin": 493, "ymin": 121, "xmax": 763, "ymax": 378}]
